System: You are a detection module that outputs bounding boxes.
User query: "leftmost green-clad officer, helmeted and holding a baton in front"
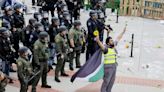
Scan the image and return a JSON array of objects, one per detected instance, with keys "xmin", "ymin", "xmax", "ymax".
[{"xmin": 17, "ymin": 47, "xmax": 39, "ymax": 92}]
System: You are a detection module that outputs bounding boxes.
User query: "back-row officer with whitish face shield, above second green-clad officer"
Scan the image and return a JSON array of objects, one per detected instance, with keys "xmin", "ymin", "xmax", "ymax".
[{"xmin": 41, "ymin": 12, "xmax": 50, "ymax": 32}]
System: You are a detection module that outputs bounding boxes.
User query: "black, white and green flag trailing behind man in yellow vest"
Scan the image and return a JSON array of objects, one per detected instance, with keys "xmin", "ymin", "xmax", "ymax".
[{"xmin": 71, "ymin": 49, "xmax": 104, "ymax": 82}]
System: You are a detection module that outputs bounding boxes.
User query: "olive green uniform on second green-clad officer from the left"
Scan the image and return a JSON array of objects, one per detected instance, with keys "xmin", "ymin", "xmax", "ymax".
[{"xmin": 33, "ymin": 39, "xmax": 49, "ymax": 86}]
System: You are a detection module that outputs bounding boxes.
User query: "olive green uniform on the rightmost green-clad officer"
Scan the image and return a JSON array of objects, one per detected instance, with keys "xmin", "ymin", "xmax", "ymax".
[{"xmin": 69, "ymin": 27, "xmax": 84, "ymax": 67}]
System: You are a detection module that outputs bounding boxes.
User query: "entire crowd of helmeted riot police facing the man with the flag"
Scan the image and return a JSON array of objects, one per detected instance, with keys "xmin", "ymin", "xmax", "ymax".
[{"xmin": 0, "ymin": 0, "xmax": 112, "ymax": 92}]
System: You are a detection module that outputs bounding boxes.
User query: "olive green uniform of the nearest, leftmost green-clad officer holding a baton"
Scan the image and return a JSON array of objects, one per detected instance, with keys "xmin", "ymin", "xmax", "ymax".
[{"xmin": 16, "ymin": 57, "xmax": 39, "ymax": 92}]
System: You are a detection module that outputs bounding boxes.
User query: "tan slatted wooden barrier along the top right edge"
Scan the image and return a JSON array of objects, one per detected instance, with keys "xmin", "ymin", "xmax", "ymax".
[{"xmin": 120, "ymin": 0, "xmax": 164, "ymax": 19}]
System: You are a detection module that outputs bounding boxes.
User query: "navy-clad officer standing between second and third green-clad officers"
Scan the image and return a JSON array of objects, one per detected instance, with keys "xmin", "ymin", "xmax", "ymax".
[{"xmin": 48, "ymin": 17, "xmax": 60, "ymax": 64}]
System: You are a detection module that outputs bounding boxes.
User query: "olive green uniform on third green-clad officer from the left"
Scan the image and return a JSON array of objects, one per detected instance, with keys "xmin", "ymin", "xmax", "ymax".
[{"xmin": 55, "ymin": 33, "xmax": 69, "ymax": 78}]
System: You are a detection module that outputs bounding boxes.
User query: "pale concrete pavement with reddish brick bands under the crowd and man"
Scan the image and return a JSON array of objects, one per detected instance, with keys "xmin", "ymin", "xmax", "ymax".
[{"xmin": 3, "ymin": 1, "xmax": 164, "ymax": 92}]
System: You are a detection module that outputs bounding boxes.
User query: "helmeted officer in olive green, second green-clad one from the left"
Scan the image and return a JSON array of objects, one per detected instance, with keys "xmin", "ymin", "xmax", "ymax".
[{"xmin": 33, "ymin": 31, "xmax": 51, "ymax": 88}]
